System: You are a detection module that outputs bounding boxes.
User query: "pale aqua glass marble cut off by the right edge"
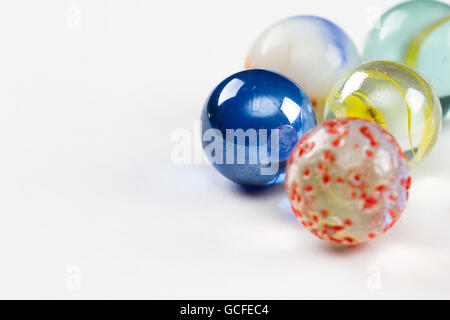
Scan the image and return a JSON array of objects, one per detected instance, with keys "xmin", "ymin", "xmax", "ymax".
[{"xmin": 363, "ymin": 1, "xmax": 450, "ymax": 111}]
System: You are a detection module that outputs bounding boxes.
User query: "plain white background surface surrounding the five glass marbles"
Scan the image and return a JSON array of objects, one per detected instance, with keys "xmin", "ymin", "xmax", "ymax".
[{"xmin": 0, "ymin": 0, "xmax": 450, "ymax": 299}]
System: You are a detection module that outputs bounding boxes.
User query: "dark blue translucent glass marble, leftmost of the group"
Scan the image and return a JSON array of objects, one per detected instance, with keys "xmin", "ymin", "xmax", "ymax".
[{"xmin": 201, "ymin": 70, "xmax": 316, "ymax": 186}]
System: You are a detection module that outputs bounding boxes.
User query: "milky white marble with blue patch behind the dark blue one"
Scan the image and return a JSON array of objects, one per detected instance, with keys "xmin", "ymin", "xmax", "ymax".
[{"xmin": 245, "ymin": 16, "xmax": 360, "ymax": 122}]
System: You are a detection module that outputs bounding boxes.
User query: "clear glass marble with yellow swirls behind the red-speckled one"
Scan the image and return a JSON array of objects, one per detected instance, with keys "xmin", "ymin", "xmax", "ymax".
[{"xmin": 325, "ymin": 61, "xmax": 442, "ymax": 167}]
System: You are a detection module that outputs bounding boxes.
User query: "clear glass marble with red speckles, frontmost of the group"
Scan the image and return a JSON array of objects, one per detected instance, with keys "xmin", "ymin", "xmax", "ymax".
[{"xmin": 285, "ymin": 118, "xmax": 411, "ymax": 245}]
